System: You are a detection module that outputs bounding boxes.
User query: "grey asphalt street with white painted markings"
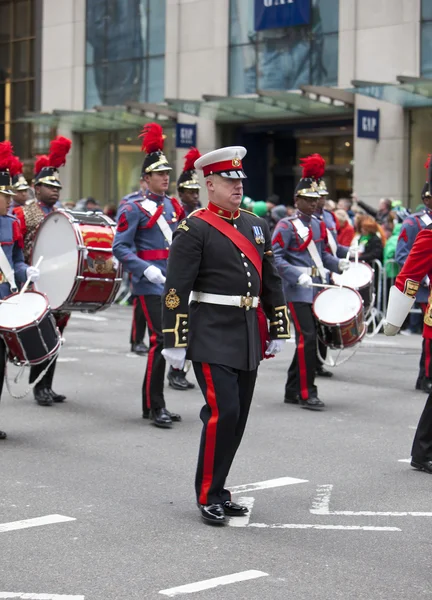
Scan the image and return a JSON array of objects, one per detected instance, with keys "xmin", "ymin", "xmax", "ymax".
[{"xmin": 0, "ymin": 306, "xmax": 432, "ymax": 600}]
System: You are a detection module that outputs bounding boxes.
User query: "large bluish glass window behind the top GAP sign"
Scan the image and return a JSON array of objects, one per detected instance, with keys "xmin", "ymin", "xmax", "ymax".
[{"xmin": 229, "ymin": 0, "xmax": 339, "ymax": 96}]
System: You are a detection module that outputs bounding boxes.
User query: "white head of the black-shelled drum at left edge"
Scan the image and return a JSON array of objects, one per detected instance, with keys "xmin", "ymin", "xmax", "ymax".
[{"xmin": 0, "ymin": 292, "xmax": 48, "ymax": 329}]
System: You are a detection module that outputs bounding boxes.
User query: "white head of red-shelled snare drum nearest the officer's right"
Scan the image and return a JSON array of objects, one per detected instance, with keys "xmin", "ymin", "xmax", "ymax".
[{"xmin": 313, "ymin": 287, "xmax": 362, "ymax": 325}]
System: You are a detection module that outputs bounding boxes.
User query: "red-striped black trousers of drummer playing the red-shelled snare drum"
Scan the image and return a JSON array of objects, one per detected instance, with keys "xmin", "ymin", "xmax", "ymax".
[{"xmin": 285, "ymin": 302, "xmax": 317, "ymax": 400}]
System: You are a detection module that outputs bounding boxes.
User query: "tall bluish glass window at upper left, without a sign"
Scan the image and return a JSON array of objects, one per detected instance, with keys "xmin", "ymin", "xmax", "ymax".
[{"xmin": 86, "ymin": 0, "xmax": 166, "ymax": 108}]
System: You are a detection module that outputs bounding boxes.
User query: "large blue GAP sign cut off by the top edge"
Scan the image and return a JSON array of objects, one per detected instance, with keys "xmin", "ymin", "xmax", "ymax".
[{"xmin": 255, "ymin": 0, "xmax": 311, "ymax": 31}]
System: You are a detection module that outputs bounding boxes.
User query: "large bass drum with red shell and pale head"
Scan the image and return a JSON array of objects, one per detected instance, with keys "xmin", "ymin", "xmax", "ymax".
[{"xmin": 32, "ymin": 210, "xmax": 122, "ymax": 311}]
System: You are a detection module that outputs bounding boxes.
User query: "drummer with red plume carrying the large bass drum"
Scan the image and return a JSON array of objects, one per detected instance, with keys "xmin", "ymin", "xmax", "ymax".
[{"xmin": 14, "ymin": 136, "xmax": 72, "ymax": 406}]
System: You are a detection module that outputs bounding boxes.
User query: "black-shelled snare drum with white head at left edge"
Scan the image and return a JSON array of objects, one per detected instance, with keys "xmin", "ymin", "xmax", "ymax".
[{"xmin": 0, "ymin": 292, "xmax": 61, "ymax": 365}]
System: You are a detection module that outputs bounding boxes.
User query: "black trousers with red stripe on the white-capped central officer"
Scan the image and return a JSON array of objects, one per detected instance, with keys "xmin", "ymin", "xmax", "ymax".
[{"xmin": 193, "ymin": 362, "xmax": 257, "ymax": 504}]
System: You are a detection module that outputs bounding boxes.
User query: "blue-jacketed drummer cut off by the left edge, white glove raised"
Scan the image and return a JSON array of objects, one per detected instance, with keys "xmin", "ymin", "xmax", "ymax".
[{"xmin": 0, "ymin": 142, "xmax": 39, "ymax": 440}]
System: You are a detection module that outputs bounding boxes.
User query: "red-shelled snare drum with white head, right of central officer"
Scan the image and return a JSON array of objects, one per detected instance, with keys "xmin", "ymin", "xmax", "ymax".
[{"xmin": 312, "ymin": 287, "xmax": 366, "ymax": 349}]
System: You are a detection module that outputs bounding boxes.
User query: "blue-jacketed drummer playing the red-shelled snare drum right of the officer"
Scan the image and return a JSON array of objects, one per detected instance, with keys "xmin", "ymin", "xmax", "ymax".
[{"xmin": 273, "ymin": 165, "xmax": 349, "ymax": 410}]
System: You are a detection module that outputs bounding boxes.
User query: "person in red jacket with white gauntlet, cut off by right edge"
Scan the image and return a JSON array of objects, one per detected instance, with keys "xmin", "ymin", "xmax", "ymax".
[{"xmin": 384, "ymin": 224, "xmax": 432, "ymax": 475}]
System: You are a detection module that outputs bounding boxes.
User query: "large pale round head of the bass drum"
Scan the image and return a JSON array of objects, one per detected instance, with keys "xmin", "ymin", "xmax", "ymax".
[{"xmin": 32, "ymin": 212, "xmax": 79, "ymax": 310}]
